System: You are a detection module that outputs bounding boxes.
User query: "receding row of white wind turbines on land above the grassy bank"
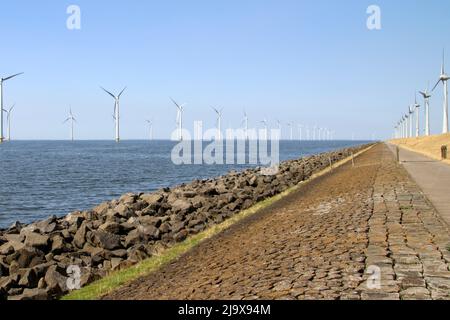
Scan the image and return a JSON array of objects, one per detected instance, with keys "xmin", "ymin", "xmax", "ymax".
[{"xmin": 394, "ymin": 50, "xmax": 450, "ymax": 139}]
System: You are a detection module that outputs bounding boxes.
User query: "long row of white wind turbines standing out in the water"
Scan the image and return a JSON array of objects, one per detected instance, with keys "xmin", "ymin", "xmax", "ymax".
[{"xmin": 0, "ymin": 72, "xmax": 334, "ymax": 142}]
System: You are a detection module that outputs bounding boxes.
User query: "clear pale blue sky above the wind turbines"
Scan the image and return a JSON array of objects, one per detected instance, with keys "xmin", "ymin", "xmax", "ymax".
[{"xmin": 0, "ymin": 0, "xmax": 450, "ymax": 139}]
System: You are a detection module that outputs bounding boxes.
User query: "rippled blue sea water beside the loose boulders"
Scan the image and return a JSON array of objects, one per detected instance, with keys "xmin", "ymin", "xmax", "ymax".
[{"xmin": 0, "ymin": 141, "xmax": 365, "ymax": 228}]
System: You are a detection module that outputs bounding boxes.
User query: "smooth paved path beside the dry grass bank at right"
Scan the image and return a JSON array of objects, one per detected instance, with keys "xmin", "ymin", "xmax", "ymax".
[{"xmin": 389, "ymin": 145, "xmax": 450, "ymax": 226}]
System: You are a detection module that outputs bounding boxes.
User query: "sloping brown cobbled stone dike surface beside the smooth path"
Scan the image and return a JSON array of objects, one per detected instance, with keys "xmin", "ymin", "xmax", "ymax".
[{"xmin": 105, "ymin": 144, "xmax": 450, "ymax": 300}]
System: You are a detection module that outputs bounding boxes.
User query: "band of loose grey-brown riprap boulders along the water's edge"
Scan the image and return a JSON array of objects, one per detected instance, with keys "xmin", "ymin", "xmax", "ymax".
[{"xmin": 0, "ymin": 145, "xmax": 368, "ymax": 300}]
